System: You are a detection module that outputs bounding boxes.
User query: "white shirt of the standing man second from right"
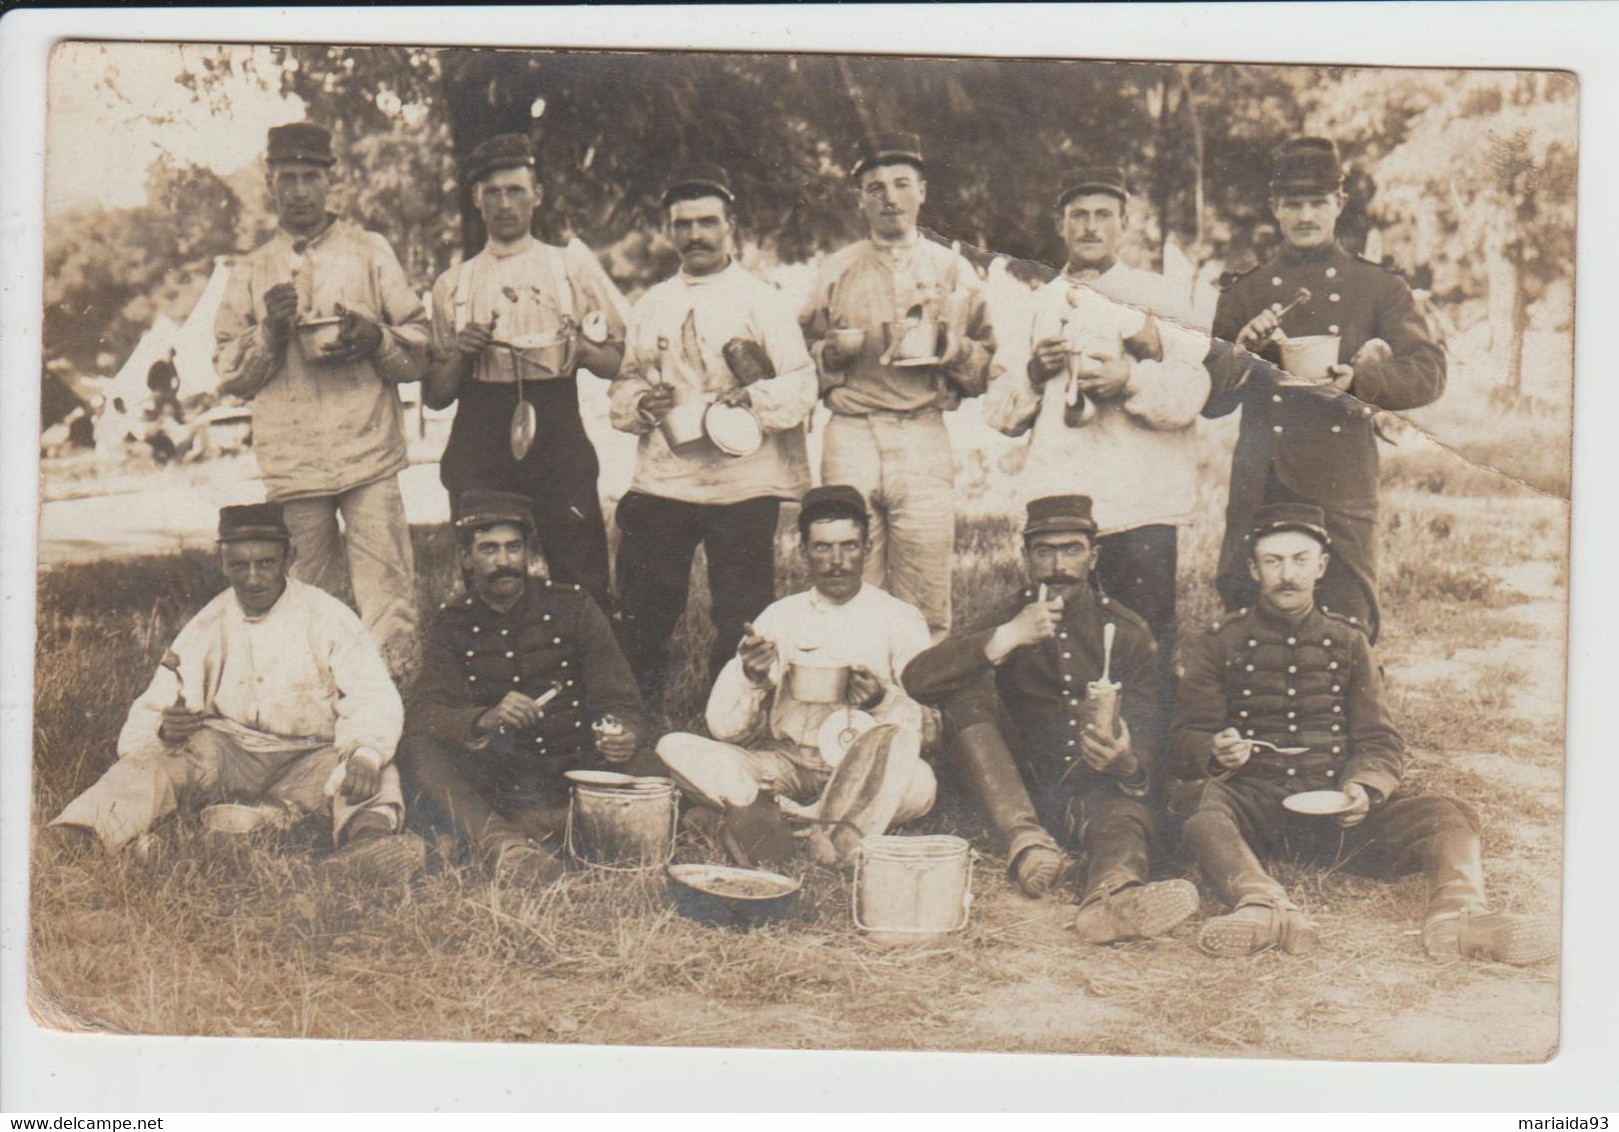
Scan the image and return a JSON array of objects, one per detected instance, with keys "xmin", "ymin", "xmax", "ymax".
[{"xmin": 983, "ymin": 264, "xmax": 1209, "ymax": 534}]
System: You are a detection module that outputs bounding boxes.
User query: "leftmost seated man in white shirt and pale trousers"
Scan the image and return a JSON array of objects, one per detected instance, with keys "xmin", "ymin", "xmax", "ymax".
[{"xmin": 50, "ymin": 504, "xmax": 423, "ymax": 879}]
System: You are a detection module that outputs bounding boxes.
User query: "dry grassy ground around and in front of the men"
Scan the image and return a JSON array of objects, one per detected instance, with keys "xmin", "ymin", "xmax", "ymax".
[{"xmin": 31, "ymin": 348, "xmax": 1569, "ymax": 1061}]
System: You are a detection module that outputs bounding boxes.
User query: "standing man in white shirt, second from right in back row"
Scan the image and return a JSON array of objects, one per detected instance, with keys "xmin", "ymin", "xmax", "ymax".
[{"xmin": 984, "ymin": 165, "xmax": 1209, "ymax": 719}]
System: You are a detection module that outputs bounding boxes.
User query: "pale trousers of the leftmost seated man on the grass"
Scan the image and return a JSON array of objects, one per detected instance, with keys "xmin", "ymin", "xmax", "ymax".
[{"xmin": 50, "ymin": 726, "xmax": 405, "ymax": 852}]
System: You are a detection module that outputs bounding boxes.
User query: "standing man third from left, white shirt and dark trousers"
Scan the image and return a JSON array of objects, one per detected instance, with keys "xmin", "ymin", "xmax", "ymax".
[{"xmin": 612, "ymin": 165, "xmax": 816, "ymax": 704}]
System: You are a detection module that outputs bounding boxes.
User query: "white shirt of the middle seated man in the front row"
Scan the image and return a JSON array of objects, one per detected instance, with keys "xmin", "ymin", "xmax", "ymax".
[{"xmin": 708, "ymin": 583, "xmax": 933, "ymax": 769}]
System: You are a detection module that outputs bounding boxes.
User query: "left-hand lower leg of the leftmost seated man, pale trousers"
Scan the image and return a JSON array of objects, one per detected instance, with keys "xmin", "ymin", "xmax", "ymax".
[{"xmin": 50, "ymin": 727, "xmax": 232, "ymax": 853}]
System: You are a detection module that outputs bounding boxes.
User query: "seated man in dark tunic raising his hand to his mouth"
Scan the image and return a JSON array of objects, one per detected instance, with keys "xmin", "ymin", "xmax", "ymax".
[{"xmin": 905, "ymin": 496, "xmax": 1198, "ymax": 944}]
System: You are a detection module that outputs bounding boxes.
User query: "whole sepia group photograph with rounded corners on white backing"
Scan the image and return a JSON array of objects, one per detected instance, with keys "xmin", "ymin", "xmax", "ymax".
[{"xmin": 12, "ymin": 24, "xmax": 1582, "ymax": 1088}]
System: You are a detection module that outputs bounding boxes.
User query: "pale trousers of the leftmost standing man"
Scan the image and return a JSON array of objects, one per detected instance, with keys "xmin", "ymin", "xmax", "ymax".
[{"xmin": 283, "ymin": 476, "xmax": 416, "ymax": 679}]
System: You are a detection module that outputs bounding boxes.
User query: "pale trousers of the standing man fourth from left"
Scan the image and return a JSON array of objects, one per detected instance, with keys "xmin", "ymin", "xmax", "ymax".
[{"xmin": 821, "ymin": 411, "xmax": 955, "ymax": 640}]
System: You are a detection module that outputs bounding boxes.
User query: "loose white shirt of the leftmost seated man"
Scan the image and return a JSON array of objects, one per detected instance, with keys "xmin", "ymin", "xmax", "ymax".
[{"xmin": 118, "ymin": 578, "xmax": 405, "ymax": 761}]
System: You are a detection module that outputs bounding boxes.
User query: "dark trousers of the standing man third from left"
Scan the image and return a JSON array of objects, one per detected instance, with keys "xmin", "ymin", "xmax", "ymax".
[{"xmin": 618, "ymin": 491, "xmax": 782, "ymax": 704}]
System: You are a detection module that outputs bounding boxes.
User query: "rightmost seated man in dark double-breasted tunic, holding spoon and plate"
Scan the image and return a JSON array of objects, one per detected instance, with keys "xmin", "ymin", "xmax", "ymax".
[{"xmin": 1171, "ymin": 504, "xmax": 1557, "ymax": 964}]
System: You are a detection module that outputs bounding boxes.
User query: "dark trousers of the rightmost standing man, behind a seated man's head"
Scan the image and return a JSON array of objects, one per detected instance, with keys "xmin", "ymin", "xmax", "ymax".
[{"xmin": 1217, "ymin": 468, "xmax": 1381, "ymax": 645}]
